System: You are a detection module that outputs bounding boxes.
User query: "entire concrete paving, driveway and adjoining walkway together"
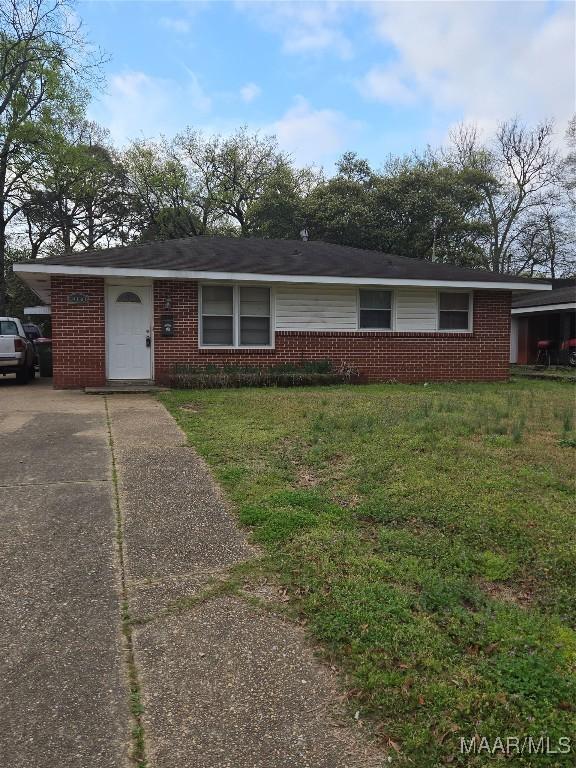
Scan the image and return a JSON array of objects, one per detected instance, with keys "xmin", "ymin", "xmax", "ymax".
[{"xmin": 0, "ymin": 380, "xmax": 384, "ymax": 768}]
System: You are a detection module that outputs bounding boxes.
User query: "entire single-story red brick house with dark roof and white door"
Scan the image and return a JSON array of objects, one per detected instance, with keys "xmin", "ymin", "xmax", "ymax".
[{"xmin": 14, "ymin": 237, "xmax": 550, "ymax": 388}]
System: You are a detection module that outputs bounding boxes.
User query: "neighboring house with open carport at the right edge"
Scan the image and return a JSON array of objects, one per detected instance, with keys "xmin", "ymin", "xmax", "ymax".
[{"xmin": 510, "ymin": 279, "xmax": 576, "ymax": 365}]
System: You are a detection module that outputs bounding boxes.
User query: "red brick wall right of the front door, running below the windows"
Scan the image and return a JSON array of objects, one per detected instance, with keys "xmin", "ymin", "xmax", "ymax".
[{"xmin": 154, "ymin": 281, "xmax": 511, "ymax": 383}]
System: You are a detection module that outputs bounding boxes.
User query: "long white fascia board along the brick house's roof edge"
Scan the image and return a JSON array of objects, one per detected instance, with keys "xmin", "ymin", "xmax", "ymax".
[{"xmin": 13, "ymin": 263, "xmax": 552, "ymax": 291}]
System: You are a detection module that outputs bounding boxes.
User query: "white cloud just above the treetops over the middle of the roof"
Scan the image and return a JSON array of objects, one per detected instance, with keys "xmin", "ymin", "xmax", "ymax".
[{"xmin": 267, "ymin": 96, "xmax": 360, "ymax": 164}]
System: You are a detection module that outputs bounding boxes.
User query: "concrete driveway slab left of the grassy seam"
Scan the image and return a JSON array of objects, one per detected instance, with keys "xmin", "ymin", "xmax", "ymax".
[{"xmin": 0, "ymin": 379, "xmax": 130, "ymax": 768}]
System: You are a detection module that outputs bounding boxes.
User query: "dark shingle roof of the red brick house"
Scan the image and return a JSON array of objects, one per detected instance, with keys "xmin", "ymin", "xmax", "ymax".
[{"xmin": 36, "ymin": 237, "xmax": 548, "ymax": 284}]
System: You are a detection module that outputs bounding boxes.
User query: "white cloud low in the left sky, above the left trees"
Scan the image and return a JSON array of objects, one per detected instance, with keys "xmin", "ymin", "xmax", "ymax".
[{"xmin": 90, "ymin": 70, "xmax": 212, "ymax": 144}]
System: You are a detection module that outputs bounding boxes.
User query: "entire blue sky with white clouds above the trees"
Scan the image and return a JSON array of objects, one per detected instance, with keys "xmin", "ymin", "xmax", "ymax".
[{"xmin": 82, "ymin": 0, "xmax": 575, "ymax": 170}]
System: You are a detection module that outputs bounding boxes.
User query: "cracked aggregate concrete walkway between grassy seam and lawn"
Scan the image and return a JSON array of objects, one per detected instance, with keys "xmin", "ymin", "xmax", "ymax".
[{"xmin": 108, "ymin": 396, "xmax": 384, "ymax": 768}]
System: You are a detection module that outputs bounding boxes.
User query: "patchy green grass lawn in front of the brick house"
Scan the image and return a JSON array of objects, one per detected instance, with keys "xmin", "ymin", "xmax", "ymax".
[{"xmin": 160, "ymin": 380, "xmax": 576, "ymax": 768}]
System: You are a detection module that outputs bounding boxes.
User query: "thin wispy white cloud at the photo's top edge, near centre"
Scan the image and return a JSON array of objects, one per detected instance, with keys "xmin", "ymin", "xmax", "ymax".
[{"xmin": 236, "ymin": 0, "xmax": 353, "ymax": 59}]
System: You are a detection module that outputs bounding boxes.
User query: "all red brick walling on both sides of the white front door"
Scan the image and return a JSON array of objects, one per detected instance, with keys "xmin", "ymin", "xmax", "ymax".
[{"xmin": 52, "ymin": 277, "xmax": 511, "ymax": 388}]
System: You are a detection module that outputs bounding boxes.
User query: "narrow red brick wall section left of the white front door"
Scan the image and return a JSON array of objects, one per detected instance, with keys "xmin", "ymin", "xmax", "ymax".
[{"xmin": 51, "ymin": 276, "xmax": 106, "ymax": 389}]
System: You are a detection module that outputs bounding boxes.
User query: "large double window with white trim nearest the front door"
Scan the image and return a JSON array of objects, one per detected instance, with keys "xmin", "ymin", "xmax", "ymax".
[{"xmin": 200, "ymin": 285, "xmax": 272, "ymax": 347}]
